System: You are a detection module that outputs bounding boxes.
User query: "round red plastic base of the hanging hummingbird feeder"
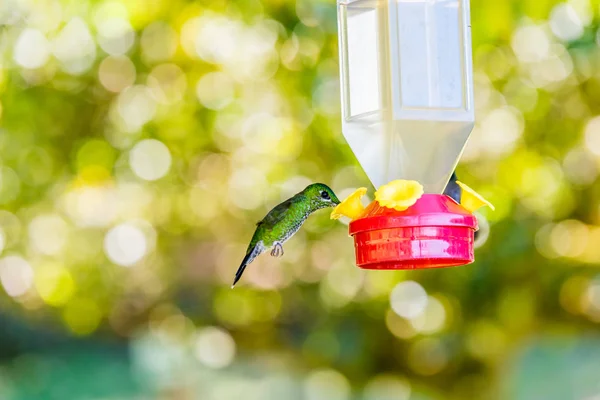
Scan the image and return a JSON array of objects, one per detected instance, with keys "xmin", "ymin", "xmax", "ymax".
[{"xmin": 349, "ymin": 194, "xmax": 478, "ymax": 269}]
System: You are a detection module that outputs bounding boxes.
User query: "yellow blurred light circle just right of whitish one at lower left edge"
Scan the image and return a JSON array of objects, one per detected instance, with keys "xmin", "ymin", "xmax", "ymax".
[{"xmin": 34, "ymin": 263, "xmax": 75, "ymax": 307}]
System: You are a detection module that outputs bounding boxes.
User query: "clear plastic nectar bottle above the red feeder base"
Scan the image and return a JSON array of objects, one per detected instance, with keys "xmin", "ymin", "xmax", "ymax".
[{"xmin": 338, "ymin": 0, "xmax": 475, "ymax": 193}]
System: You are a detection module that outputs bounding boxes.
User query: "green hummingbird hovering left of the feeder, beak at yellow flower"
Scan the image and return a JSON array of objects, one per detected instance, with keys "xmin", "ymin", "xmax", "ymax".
[{"xmin": 231, "ymin": 183, "xmax": 340, "ymax": 288}]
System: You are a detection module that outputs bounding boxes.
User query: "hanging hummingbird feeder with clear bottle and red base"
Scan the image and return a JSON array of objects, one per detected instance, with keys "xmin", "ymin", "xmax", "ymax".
[{"xmin": 338, "ymin": 0, "xmax": 477, "ymax": 269}]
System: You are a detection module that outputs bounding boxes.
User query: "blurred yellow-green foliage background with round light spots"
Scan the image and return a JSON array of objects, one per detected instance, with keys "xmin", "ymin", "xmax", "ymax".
[{"xmin": 0, "ymin": 0, "xmax": 600, "ymax": 400}]
